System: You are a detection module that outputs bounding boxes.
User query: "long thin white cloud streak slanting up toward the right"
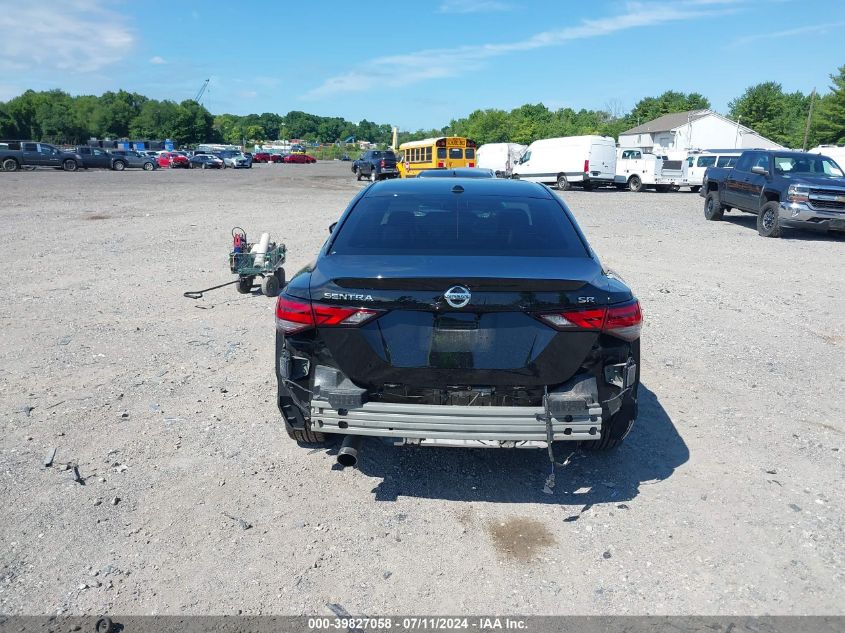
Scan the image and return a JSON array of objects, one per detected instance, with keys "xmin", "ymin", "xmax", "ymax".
[{"xmin": 303, "ymin": 0, "xmax": 734, "ymax": 99}]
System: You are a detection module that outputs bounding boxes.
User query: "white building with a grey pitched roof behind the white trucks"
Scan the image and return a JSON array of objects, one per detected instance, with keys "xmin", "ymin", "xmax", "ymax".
[{"xmin": 619, "ymin": 110, "xmax": 783, "ymax": 160}]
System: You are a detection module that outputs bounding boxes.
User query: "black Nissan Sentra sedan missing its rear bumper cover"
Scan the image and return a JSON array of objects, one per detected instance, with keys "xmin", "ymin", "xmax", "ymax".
[{"xmin": 276, "ymin": 178, "xmax": 642, "ymax": 463}]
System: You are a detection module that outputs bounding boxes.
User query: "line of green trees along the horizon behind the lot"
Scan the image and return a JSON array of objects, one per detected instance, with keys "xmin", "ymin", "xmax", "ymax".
[{"xmin": 0, "ymin": 66, "xmax": 845, "ymax": 147}]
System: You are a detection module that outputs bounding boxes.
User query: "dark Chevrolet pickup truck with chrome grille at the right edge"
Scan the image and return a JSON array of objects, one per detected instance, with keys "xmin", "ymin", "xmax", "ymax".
[{"xmin": 700, "ymin": 150, "xmax": 845, "ymax": 237}]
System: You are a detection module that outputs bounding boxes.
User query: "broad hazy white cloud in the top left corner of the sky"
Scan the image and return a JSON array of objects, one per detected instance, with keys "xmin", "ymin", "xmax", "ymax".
[{"xmin": 0, "ymin": 0, "xmax": 135, "ymax": 73}]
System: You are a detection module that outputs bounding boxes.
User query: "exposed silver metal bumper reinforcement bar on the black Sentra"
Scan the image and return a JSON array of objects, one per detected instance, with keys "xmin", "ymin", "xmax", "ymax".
[{"xmin": 311, "ymin": 398, "xmax": 602, "ymax": 448}]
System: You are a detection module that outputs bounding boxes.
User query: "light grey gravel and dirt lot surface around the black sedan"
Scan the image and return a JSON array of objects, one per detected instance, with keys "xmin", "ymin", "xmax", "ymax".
[{"xmin": 0, "ymin": 163, "xmax": 845, "ymax": 615}]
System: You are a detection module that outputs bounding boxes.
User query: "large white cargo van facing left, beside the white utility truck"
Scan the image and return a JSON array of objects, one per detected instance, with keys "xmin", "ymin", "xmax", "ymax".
[{"xmin": 513, "ymin": 136, "xmax": 616, "ymax": 191}]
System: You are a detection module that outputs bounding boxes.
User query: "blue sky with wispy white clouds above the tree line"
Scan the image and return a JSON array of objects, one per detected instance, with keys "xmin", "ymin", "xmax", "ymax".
[{"xmin": 0, "ymin": 0, "xmax": 845, "ymax": 130}]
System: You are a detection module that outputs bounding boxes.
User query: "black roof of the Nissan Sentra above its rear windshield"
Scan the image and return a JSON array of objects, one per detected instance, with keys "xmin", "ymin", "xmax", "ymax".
[{"xmin": 364, "ymin": 178, "xmax": 553, "ymax": 198}]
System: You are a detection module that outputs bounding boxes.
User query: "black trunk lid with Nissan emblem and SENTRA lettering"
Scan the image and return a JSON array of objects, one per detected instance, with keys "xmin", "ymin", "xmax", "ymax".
[{"xmin": 310, "ymin": 255, "xmax": 631, "ymax": 389}]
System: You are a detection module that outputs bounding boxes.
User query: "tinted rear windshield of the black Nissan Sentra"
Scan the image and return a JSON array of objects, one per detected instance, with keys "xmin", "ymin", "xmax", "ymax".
[{"xmin": 331, "ymin": 193, "xmax": 588, "ymax": 257}]
